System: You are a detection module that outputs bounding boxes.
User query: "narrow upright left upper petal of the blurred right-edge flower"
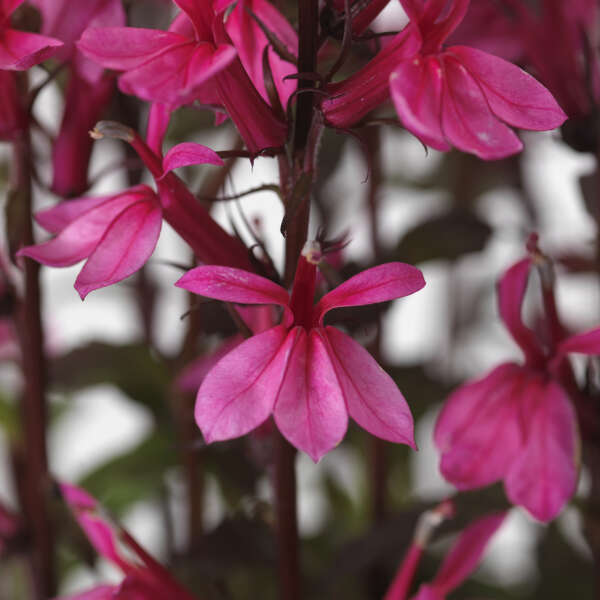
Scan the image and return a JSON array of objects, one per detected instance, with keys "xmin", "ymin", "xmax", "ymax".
[{"xmin": 498, "ymin": 258, "xmax": 542, "ymax": 361}]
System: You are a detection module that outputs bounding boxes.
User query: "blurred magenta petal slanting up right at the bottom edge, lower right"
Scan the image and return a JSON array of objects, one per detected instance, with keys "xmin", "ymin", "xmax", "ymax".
[{"xmin": 433, "ymin": 512, "xmax": 507, "ymax": 593}]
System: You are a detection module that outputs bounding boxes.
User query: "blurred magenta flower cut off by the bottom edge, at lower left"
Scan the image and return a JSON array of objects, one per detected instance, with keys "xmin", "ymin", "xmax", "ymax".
[{"xmin": 56, "ymin": 483, "xmax": 194, "ymax": 600}]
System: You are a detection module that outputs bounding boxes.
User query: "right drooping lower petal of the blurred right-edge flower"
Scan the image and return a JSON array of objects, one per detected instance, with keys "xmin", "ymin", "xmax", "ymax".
[{"xmin": 505, "ymin": 380, "xmax": 579, "ymax": 521}]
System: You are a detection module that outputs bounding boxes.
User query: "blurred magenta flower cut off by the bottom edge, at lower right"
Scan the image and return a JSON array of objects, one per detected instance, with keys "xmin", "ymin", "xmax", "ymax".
[{"xmin": 384, "ymin": 511, "xmax": 507, "ymax": 600}]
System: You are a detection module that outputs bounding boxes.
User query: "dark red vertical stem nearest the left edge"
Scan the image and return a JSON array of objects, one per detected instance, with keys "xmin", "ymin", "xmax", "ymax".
[{"xmin": 11, "ymin": 130, "xmax": 56, "ymax": 600}]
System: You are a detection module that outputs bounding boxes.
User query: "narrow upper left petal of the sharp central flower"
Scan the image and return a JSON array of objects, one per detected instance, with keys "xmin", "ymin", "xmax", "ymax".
[{"xmin": 175, "ymin": 265, "xmax": 289, "ymax": 306}]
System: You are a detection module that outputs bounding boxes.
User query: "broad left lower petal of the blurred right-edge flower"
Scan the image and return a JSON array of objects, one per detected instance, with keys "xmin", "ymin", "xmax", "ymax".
[{"xmin": 434, "ymin": 363, "xmax": 528, "ymax": 490}]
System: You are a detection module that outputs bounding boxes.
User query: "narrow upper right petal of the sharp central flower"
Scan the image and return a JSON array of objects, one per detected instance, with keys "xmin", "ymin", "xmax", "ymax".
[{"xmin": 314, "ymin": 262, "xmax": 425, "ymax": 324}]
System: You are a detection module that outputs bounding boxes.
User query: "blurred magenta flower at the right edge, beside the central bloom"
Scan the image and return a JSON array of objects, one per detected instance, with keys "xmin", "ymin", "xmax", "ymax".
[{"xmin": 434, "ymin": 239, "xmax": 600, "ymax": 521}]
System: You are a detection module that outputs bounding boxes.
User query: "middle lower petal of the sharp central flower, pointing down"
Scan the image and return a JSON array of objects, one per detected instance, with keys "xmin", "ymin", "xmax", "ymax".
[{"xmin": 274, "ymin": 327, "xmax": 348, "ymax": 462}]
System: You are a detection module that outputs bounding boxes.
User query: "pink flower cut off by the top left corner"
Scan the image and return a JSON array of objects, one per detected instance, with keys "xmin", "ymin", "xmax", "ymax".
[{"xmin": 0, "ymin": 0, "xmax": 63, "ymax": 71}]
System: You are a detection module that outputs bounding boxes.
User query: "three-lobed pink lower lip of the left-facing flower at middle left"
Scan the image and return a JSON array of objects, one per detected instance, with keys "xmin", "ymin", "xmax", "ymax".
[{"xmin": 17, "ymin": 185, "xmax": 162, "ymax": 299}]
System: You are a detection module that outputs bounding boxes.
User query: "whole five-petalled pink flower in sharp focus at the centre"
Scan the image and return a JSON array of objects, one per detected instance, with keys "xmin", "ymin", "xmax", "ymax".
[{"xmin": 175, "ymin": 242, "xmax": 425, "ymax": 461}]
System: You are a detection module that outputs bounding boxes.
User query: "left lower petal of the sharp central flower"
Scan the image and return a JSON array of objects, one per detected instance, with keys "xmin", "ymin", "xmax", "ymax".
[{"xmin": 195, "ymin": 325, "xmax": 294, "ymax": 443}]
